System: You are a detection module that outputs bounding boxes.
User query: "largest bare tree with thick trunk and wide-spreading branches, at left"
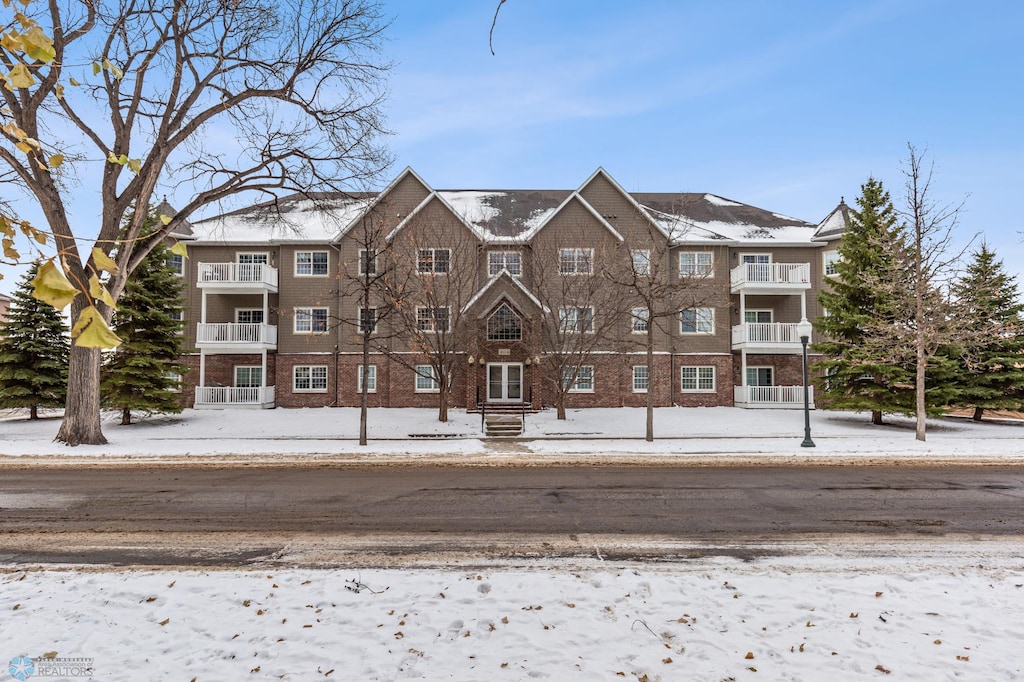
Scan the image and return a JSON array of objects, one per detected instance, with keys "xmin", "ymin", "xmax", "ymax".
[{"xmin": 0, "ymin": 0, "xmax": 388, "ymax": 444}]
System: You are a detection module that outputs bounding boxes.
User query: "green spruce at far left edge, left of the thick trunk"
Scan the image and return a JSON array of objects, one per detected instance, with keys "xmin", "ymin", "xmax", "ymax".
[{"xmin": 0, "ymin": 265, "xmax": 71, "ymax": 419}]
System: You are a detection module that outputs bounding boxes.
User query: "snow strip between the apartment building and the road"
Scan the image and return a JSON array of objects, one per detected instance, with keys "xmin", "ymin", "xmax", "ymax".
[{"xmin": 0, "ymin": 408, "xmax": 1024, "ymax": 462}]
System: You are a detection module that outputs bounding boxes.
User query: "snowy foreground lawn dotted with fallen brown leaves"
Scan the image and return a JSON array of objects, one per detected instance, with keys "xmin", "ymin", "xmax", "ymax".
[{"xmin": 0, "ymin": 550, "xmax": 1024, "ymax": 682}]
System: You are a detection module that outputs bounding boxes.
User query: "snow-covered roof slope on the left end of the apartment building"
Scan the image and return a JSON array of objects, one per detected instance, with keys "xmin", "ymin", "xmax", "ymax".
[{"xmin": 191, "ymin": 195, "xmax": 373, "ymax": 243}]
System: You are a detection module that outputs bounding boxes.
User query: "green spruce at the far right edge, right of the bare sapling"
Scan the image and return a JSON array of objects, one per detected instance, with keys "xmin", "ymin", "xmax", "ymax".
[{"xmin": 952, "ymin": 244, "xmax": 1024, "ymax": 421}]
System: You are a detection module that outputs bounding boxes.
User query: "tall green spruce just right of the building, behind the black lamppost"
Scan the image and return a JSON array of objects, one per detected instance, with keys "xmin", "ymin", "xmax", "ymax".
[{"xmin": 814, "ymin": 178, "xmax": 914, "ymax": 424}]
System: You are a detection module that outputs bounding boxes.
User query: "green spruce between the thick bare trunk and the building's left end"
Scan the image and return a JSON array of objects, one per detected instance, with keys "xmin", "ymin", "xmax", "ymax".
[{"xmin": 100, "ymin": 211, "xmax": 185, "ymax": 425}]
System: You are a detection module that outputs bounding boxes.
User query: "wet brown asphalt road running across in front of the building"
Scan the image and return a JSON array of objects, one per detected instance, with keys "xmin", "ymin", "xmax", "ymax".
[{"xmin": 0, "ymin": 466, "xmax": 1024, "ymax": 563}]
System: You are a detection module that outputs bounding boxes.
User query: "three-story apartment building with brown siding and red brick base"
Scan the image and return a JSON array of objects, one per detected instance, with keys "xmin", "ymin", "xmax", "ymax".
[{"xmin": 179, "ymin": 169, "xmax": 846, "ymax": 409}]
